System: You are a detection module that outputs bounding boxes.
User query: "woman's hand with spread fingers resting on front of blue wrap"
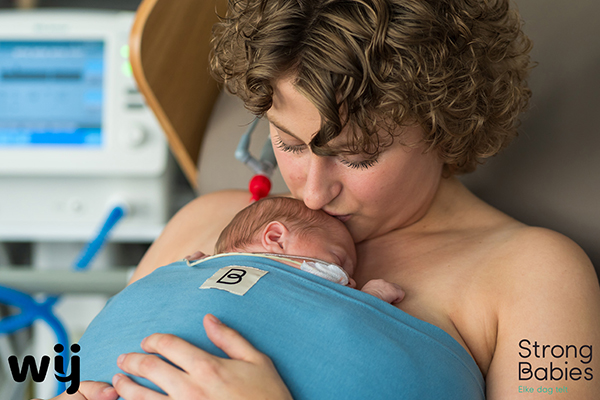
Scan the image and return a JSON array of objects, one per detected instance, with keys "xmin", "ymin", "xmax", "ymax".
[{"xmin": 113, "ymin": 314, "xmax": 292, "ymax": 400}]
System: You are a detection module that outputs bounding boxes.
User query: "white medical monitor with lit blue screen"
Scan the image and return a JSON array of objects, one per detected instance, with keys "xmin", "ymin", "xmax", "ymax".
[{"xmin": 0, "ymin": 10, "xmax": 172, "ymax": 242}]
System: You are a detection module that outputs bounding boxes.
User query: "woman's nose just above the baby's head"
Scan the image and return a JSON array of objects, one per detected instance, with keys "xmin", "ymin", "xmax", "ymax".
[{"xmin": 302, "ymin": 154, "xmax": 342, "ymax": 210}]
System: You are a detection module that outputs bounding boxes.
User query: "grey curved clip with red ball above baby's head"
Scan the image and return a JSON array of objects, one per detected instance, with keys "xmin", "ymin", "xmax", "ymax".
[{"xmin": 235, "ymin": 118, "xmax": 277, "ymax": 202}]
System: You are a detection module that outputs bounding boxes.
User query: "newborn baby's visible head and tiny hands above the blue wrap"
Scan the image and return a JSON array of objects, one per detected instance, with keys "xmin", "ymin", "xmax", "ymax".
[{"xmin": 185, "ymin": 197, "xmax": 404, "ymax": 304}]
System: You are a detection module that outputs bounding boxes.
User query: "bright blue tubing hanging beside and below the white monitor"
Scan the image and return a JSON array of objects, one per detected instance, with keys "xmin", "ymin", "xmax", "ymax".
[{"xmin": 0, "ymin": 205, "xmax": 126, "ymax": 396}]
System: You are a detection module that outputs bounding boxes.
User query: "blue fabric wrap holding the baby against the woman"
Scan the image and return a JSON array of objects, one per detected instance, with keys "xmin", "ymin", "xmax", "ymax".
[{"xmin": 79, "ymin": 255, "xmax": 485, "ymax": 400}]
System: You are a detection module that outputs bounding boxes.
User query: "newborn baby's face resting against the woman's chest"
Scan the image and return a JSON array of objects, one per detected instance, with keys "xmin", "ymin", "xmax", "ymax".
[{"xmin": 287, "ymin": 217, "xmax": 356, "ymax": 276}]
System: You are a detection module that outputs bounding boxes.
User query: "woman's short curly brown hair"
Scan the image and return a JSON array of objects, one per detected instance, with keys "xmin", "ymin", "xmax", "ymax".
[{"xmin": 211, "ymin": 0, "xmax": 531, "ymax": 174}]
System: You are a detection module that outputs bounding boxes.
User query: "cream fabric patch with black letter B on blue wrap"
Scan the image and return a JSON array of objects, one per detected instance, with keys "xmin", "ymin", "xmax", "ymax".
[{"xmin": 200, "ymin": 265, "xmax": 268, "ymax": 296}]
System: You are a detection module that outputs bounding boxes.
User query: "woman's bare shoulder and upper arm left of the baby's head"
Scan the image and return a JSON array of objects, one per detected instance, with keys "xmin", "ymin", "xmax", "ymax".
[{"xmin": 129, "ymin": 190, "xmax": 250, "ymax": 283}]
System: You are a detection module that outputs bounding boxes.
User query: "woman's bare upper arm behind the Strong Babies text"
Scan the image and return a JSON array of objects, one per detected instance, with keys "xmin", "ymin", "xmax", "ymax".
[{"xmin": 486, "ymin": 228, "xmax": 600, "ymax": 400}]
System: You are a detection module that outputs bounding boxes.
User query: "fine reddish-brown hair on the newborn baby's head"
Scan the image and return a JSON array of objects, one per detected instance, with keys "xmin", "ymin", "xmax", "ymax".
[{"xmin": 215, "ymin": 197, "xmax": 333, "ymax": 254}]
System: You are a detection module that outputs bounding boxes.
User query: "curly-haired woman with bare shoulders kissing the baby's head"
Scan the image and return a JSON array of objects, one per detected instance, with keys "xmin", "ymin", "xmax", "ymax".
[{"xmin": 58, "ymin": 0, "xmax": 600, "ymax": 400}]
